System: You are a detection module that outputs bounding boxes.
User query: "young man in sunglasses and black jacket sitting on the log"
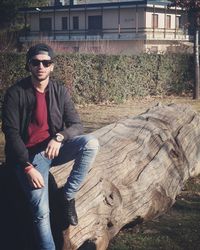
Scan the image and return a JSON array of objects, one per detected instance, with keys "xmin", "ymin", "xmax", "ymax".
[{"xmin": 2, "ymin": 44, "xmax": 99, "ymax": 250}]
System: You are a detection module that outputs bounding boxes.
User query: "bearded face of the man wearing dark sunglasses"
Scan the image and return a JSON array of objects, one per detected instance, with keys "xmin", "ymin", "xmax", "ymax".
[{"xmin": 29, "ymin": 54, "xmax": 54, "ymax": 82}]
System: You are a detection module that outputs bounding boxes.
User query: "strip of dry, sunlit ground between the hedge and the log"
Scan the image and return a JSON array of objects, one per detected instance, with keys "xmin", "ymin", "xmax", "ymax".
[{"xmin": 78, "ymin": 96, "xmax": 200, "ymax": 132}]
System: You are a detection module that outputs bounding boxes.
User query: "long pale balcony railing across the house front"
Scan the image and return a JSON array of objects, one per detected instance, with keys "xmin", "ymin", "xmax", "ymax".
[{"xmin": 20, "ymin": 28, "xmax": 189, "ymax": 41}]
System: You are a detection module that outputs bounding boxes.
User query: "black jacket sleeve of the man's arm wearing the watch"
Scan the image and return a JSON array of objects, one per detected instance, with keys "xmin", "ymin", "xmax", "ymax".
[{"xmin": 59, "ymin": 88, "xmax": 83, "ymax": 140}]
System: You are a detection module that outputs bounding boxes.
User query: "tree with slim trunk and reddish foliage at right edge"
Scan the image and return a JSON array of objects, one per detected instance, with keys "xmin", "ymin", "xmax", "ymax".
[{"xmin": 170, "ymin": 0, "xmax": 200, "ymax": 99}]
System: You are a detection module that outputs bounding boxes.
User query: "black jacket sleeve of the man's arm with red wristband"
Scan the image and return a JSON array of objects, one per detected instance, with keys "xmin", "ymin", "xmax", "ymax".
[{"xmin": 2, "ymin": 88, "xmax": 29, "ymax": 167}]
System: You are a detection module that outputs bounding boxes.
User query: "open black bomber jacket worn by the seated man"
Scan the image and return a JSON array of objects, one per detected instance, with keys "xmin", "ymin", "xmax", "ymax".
[{"xmin": 2, "ymin": 77, "xmax": 83, "ymax": 167}]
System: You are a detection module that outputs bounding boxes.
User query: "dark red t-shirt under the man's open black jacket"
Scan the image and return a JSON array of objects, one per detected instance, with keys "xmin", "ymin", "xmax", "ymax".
[{"xmin": 26, "ymin": 90, "xmax": 50, "ymax": 147}]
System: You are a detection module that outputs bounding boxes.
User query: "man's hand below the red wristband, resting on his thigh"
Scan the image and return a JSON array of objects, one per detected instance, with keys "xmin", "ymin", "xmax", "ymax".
[{"xmin": 26, "ymin": 167, "xmax": 44, "ymax": 188}]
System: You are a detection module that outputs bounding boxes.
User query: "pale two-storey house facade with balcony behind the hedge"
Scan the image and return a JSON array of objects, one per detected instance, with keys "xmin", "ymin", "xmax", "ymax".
[{"xmin": 20, "ymin": 0, "xmax": 190, "ymax": 55}]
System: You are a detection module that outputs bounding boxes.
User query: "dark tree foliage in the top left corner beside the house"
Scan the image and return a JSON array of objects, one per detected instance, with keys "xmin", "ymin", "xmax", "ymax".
[{"xmin": 0, "ymin": 0, "xmax": 49, "ymax": 28}]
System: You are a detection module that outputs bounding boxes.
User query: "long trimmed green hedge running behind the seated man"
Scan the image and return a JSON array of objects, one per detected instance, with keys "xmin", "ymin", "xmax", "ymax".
[{"xmin": 0, "ymin": 53, "xmax": 194, "ymax": 103}]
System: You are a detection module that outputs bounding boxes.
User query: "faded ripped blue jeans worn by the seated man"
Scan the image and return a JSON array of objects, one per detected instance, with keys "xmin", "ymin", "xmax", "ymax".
[{"xmin": 16, "ymin": 135, "xmax": 99, "ymax": 250}]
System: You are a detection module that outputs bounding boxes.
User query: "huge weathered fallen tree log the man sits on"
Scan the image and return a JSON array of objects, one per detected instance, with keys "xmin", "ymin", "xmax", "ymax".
[{"xmin": 51, "ymin": 104, "xmax": 200, "ymax": 250}]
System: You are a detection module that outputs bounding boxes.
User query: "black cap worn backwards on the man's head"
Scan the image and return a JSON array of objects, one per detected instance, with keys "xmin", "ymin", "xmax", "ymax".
[{"xmin": 25, "ymin": 43, "xmax": 54, "ymax": 70}]
